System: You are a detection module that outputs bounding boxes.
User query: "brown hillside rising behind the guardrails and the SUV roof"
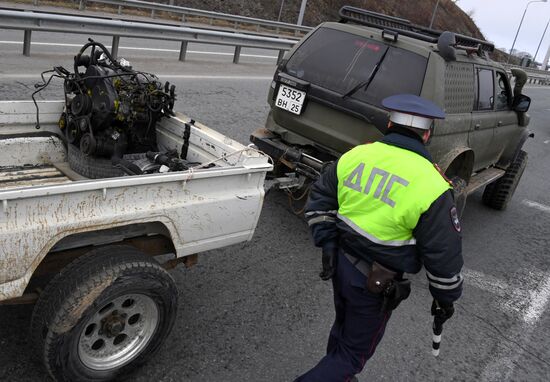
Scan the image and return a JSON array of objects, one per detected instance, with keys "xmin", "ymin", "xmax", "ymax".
[{"xmin": 175, "ymin": 0, "xmax": 483, "ymax": 38}]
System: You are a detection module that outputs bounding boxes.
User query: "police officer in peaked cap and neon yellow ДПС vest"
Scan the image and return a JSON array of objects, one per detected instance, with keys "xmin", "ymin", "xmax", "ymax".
[{"xmin": 296, "ymin": 94, "xmax": 463, "ymax": 382}]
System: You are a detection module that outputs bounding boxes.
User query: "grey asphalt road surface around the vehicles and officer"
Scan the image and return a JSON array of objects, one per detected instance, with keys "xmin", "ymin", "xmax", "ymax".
[{"xmin": 0, "ymin": 31, "xmax": 550, "ymax": 382}]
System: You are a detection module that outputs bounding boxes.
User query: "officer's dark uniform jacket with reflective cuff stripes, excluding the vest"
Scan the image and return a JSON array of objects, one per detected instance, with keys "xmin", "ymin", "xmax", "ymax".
[{"xmin": 305, "ymin": 131, "xmax": 463, "ymax": 302}]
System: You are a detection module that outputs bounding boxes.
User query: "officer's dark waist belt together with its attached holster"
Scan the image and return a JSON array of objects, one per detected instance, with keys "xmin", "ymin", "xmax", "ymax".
[{"xmin": 344, "ymin": 252, "xmax": 411, "ymax": 312}]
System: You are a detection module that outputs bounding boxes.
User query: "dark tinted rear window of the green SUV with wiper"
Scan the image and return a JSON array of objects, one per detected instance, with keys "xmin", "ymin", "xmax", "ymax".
[{"xmin": 285, "ymin": 28, "xmax": 427, "ymax": 106}]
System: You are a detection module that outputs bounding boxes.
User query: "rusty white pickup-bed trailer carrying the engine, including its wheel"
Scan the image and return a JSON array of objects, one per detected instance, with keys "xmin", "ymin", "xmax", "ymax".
[{"xmin": 0, "ymin": 101, "xmax": 272, "ymax": 381}]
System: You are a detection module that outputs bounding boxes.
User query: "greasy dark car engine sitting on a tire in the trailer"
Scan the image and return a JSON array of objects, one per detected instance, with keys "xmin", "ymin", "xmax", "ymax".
[{"xmin": 62, "ymin": 41, "xmax": 175, "ymax": 158}]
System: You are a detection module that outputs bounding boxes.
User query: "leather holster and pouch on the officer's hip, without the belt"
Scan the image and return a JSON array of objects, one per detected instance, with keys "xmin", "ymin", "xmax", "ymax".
[{"xmin": 367, "ymin": 261, "xmax": 411, "ymax": 312}]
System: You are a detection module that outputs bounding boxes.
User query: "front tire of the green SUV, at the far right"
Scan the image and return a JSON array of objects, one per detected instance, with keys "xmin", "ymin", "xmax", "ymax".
[{"xmin": 482, "ymin": 150, "xmax": 528, "ymax": 210}]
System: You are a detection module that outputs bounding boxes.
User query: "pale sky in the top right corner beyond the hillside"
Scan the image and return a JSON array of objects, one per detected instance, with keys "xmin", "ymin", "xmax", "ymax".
[{"xmin": 456, "ymin": 0, "xmax": 550, "ymax": 62}]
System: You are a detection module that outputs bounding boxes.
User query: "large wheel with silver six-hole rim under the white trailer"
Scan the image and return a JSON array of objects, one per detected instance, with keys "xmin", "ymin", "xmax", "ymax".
[{"xmin": 31, "ymin": 246, "xmax": 177, "ymax": 381}]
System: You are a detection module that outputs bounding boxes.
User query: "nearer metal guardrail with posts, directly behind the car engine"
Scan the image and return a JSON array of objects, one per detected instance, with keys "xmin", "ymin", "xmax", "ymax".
[{"xmin": 0, "ymin": 10, "xmax": 297, "ymax": 64}]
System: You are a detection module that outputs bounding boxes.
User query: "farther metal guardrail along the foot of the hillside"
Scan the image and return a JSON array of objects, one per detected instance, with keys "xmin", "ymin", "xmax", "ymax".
[{"xmin": 29, "ymin": 0, "xmax": 313, "ymax": 36}]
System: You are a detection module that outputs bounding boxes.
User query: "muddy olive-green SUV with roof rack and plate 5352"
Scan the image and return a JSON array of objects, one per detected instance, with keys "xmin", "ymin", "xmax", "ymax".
[{"xmin": 251, "ymin": 6, "xmax": 532, "ymax": 213}]
